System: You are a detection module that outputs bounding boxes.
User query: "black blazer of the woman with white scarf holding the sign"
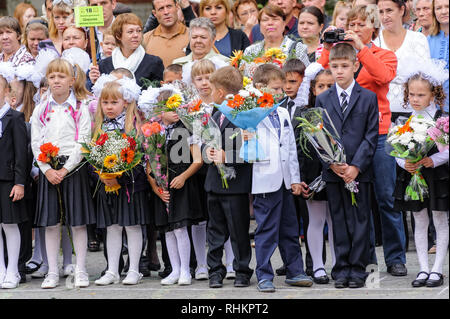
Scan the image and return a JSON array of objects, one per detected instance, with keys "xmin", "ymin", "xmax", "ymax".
[{"xmin": 98, "ymin": 53, "xmax": 164, "ymax": 86}]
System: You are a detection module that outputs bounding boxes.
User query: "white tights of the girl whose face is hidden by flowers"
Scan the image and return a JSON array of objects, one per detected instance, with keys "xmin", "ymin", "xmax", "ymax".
[{"xmin": 166, "ymin": 227, "xmax": 191, "ymax": 278}]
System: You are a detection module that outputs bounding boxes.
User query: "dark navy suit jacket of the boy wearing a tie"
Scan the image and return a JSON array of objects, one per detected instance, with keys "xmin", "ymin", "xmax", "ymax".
[{"xmin": 316, "ymin": 83, "xmax": 379, "ymax": 182}]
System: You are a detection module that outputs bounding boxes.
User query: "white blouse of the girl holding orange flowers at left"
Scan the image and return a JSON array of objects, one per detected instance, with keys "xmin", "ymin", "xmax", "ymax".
[{"xmin": 31, "ymin": 92, "xmax": 91, "ymax": 174}]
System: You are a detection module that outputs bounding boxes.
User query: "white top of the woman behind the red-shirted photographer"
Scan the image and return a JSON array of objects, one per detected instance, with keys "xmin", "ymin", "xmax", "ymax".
[{"xmin": 373, "ymin": 30, "xmax": 431, "ymax": 113}]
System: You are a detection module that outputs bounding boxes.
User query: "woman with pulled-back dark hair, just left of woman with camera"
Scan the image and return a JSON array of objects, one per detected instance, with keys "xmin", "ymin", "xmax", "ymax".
[{"xmin": 298, "ymin": 6, "xmax": 324, "ymax": 62}]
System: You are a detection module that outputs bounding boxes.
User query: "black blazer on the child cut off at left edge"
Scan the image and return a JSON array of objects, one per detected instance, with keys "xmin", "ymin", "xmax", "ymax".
[{"xmin": 0, "ymin": 109, "xmax": 30, "ymax": 185}]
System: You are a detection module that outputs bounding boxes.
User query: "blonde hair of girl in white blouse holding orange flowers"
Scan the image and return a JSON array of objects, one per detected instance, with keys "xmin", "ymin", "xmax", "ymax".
[{"xmin": 46, "ymin": 59, "xmax": 91, "ymax": 101}]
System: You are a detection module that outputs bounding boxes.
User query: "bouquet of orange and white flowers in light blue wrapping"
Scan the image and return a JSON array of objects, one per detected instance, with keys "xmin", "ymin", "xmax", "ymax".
[{"xmin": 216, "ymin": 85, "xmax": 280, "ymax": 162}]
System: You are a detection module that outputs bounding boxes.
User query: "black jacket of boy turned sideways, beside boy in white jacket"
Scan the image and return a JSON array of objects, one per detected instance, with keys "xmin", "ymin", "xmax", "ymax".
[{"xmin": 202, "ymin": 111, "xmax": 253, "ymax": 195}]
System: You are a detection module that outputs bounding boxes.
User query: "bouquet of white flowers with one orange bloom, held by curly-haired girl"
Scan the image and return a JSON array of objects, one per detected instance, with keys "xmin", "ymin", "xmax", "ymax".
[{"xmin": 386, "ymin": 115, "xmax": 435, "ymax": 202}]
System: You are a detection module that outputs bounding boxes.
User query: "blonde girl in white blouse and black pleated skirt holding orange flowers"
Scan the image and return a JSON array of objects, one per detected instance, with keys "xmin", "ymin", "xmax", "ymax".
[{"xmin": 31, "ymin": 59, "xmax": 95, "ymax": 288}]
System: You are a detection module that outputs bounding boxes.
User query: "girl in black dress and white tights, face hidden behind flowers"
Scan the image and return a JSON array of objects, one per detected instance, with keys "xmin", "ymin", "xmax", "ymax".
[{"xmin": 150, "ymin": 89, "xmax": 206, "ymax": 285}]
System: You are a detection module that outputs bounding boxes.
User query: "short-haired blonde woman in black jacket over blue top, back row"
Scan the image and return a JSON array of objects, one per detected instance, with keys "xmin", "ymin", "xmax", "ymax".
[{"xmin": 199, "ymin": 0, "xmax": 250, "ymax": 57}]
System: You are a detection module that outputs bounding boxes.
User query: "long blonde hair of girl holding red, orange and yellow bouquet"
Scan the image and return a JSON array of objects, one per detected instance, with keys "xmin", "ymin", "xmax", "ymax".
[{"xmin": 94, "ymin": 81, "xmax": 141, "ymax": 139}]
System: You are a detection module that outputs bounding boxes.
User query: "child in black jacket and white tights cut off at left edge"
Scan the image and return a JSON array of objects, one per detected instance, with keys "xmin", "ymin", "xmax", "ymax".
[{"xmin": 0, "ymin": 72, "xmax": 29, "ymax": 289}]
